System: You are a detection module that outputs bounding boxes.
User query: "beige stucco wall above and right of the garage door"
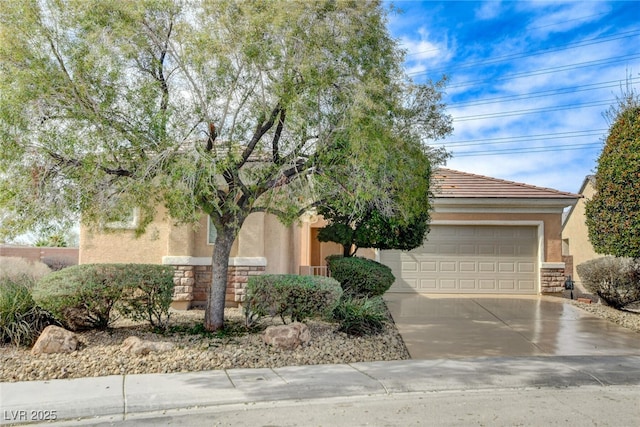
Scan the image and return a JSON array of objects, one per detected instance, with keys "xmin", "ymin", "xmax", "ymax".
[{"xmin": 431, "ymin": 212, "xmax": 562, "ymax": 263}]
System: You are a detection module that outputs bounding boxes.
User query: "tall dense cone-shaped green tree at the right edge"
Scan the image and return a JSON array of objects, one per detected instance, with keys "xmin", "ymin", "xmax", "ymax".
[{"xmin": 586, "ymin": 91, "xmax": 640, "ymax": 258}]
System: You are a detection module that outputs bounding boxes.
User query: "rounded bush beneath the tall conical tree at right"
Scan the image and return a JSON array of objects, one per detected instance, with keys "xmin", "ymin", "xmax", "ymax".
[{"xmin": 577, "ymin": 257, "xmax": 640, "ymax": 309}]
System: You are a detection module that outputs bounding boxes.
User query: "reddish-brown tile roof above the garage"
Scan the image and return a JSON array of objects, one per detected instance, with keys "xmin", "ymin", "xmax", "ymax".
[{"xmin": 433, "ymin": 168, "xmax": 581, "ymax": 199}]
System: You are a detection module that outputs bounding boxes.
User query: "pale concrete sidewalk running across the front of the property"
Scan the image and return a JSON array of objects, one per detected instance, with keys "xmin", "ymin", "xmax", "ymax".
[{"xmin": 0, "ymin": 356, "xmax": 640, "ymax": 425}]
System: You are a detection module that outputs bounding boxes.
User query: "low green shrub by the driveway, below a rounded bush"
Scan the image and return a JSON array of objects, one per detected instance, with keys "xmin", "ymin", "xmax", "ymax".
[{"xmin": 333, "ymin": 295, "xmax": 388, "ymax": 336}]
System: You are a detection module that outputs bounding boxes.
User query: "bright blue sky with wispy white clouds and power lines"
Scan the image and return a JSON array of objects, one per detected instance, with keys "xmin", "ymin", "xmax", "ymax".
[{"xmin": 387, "ymin": 1, "xmax": 640, "ymax": 193}]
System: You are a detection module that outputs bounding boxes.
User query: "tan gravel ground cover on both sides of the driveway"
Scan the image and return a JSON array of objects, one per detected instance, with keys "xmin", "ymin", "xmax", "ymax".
[{"xmin": 0, "ymin": 301, "xmax": 640, "ymax": 382}]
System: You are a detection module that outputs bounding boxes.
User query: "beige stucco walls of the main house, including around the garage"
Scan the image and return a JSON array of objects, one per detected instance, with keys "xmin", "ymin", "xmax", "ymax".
[{"xmin": 80, "ymin": 201, "xmax": 563, "ymax": 280}]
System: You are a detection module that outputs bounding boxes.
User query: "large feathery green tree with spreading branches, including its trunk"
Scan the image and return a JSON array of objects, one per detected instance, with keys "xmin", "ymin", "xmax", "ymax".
[{"xmin": 0, "ymin": 0, "xmax": 450, "ymax": 330}]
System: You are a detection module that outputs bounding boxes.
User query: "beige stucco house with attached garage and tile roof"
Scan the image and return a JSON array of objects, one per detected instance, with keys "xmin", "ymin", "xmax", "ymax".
[{"xmin": 80, "ymin": 169, "xmax": 580, "ymax": 308}]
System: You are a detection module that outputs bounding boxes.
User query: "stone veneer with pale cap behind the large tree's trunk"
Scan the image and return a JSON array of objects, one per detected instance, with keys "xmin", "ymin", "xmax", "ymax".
[{"xmin": 163, "ymin": 257, "xmax": 266, "ymax": 308}]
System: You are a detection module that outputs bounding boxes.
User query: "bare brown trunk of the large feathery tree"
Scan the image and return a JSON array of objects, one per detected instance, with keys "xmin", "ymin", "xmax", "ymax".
[{"xmin": 204, "ymin": 228, "xmax": 236, "ymax": 331}]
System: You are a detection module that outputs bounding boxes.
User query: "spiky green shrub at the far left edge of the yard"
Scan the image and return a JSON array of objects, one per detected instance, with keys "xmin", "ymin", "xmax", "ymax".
[{"xmin": 0, "ymin": 276, "xmax": 55, "ymax": 346}]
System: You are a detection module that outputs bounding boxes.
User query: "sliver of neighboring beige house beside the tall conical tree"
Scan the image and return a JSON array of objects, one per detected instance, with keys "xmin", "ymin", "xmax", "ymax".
[{"xmin": 562, "ymin": 175, "xmax": 604, "ymax": 285}]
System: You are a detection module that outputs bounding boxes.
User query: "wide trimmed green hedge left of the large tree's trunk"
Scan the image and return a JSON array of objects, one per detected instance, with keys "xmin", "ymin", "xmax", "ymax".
[{"xmin": 33, "ymin": 264, "xmax": 173, "ymax": 330}]
